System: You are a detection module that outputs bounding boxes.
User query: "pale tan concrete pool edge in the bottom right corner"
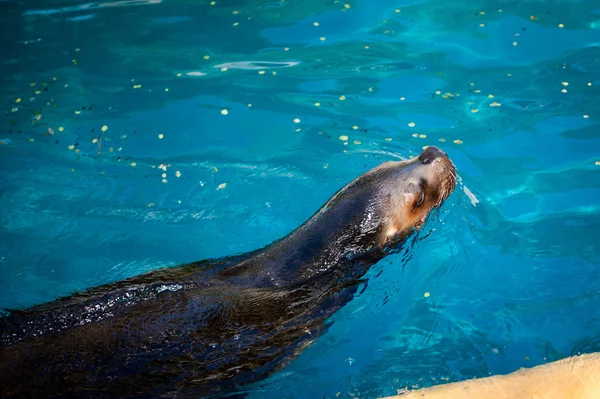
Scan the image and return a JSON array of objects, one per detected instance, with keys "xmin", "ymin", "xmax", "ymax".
[{"xmin": 382, "ymin": 352, "xmax": 600, "ymax": 399}]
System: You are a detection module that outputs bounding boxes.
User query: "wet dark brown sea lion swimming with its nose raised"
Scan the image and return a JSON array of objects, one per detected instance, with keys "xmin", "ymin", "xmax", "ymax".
[{"xmin": 0, "ymin": 147, "xmax": 456, "ymax": 398}]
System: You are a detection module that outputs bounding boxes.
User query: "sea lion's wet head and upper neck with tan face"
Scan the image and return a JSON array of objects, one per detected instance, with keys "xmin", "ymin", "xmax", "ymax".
[{"xmin": 315, "ymin": 146, "xmax": 456, "ymax": 253}]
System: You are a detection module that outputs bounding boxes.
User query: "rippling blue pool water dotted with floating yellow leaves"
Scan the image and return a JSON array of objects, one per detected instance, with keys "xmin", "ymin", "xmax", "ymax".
[{"xmin": 0, "ymin": 0, "xmax": 600, "ymax": 398}]
